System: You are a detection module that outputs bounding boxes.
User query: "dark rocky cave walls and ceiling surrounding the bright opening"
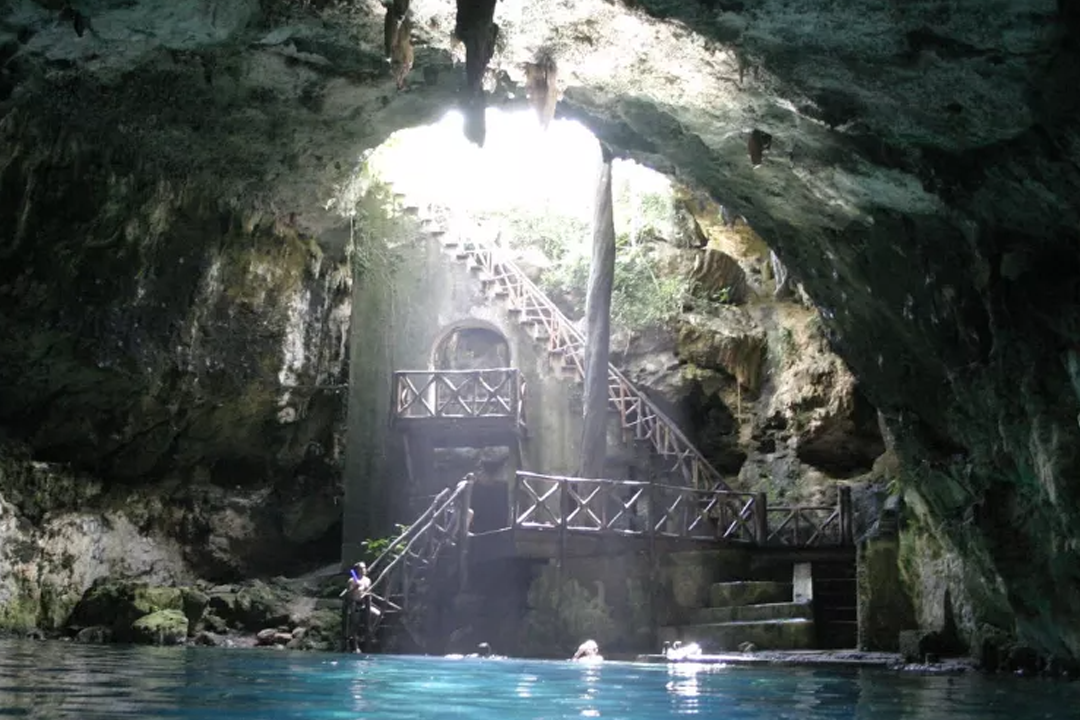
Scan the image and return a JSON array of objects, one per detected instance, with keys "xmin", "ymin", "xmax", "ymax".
[{"xmin": 0, "ymin": 0, "xmax": 1080, "ymax": 660}]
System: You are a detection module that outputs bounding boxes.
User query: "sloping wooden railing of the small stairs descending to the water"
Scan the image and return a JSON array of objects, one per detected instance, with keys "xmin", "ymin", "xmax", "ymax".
[{"xmin": 356, "ymin": 475, "xmax": 474, "ymax": 648}]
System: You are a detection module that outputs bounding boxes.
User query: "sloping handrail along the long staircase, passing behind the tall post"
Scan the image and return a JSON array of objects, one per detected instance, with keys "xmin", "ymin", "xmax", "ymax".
[{"xmin": 462, "ymin": 241, "xmax": 731, "ymax": 491}]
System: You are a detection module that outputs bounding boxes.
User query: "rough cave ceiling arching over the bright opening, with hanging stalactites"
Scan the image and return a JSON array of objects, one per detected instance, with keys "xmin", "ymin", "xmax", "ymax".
[{"xmin": 0, "ymin": 0, "xmax": 1080, "ymax": 424}]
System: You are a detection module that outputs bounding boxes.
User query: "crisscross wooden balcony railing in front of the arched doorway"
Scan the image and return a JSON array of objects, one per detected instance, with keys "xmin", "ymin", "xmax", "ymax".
[{"xmin": 393, "ymin": 367, "xmax": 525, "ymax": 423}]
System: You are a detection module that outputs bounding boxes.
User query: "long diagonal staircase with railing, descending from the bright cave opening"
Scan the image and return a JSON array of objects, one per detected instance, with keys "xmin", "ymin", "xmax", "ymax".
[{"xmin": 412, "ymin": 217, "xmax": 731, "ymax": 490}]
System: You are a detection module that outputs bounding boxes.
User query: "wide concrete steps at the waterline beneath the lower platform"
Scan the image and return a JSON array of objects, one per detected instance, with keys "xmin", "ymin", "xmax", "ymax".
[{"xmin": 660, "ymin": 581, "xmax": 816, "ymax": 653}]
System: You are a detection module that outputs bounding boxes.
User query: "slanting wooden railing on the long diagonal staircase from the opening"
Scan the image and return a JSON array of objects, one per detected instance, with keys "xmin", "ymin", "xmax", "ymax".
[{"xmin": 459, "ymin": 243, "xmax": 731, "ymax": 491}]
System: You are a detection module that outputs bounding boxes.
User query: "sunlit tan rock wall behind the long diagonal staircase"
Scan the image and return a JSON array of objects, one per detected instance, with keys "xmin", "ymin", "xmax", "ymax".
[{"xmin": 612, "ymin": 209, "xmax": 886, "ymax": 511}]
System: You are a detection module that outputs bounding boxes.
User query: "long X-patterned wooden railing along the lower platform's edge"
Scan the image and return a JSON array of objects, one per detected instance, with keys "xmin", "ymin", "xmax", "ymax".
[{"xmin": 509, "ymin": 472, "xmax": 851, "ymax": 547}]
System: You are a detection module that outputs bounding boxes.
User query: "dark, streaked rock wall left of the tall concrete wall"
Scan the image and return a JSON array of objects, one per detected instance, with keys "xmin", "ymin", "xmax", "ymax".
[{"xmin": 0, "ymin": 105, "xmax": 351, "ymax": 586}]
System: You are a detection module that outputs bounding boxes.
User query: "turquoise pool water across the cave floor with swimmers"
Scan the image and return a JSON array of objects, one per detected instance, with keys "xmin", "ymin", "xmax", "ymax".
[{"xmin": 0, "ymin": 641, "xmax": 1080, "ymax": 720}]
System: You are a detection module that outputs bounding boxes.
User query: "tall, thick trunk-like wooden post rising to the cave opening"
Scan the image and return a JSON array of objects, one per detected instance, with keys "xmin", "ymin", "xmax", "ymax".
[{"xmin": 578, "ymin": 144, "xmax": 615, "ymax": 478}]
